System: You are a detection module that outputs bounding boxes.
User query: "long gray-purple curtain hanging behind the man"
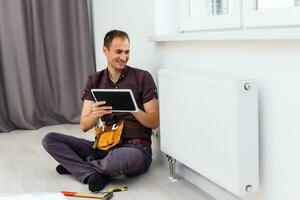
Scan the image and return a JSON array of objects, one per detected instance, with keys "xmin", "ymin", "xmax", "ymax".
[{"xmin": 0, "ymin": 0, "xmax": 95, "ymax": 132}]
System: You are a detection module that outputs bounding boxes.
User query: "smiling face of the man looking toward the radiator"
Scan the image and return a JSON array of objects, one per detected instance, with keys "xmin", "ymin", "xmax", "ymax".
[{"xmin": 103, "ymin": 37, "xmax": 130, "ymax": 70}]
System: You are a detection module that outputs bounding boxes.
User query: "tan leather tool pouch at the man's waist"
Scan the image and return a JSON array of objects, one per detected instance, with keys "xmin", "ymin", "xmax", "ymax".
[{"xmin": 93, "ymin": 121, "xmax": 124, "ymax": 150}]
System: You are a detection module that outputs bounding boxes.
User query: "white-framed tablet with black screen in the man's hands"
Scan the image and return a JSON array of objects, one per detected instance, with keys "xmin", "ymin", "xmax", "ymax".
[{"xmin": 91, "ymin": 89, "xmax": 138, "ymax": 112}]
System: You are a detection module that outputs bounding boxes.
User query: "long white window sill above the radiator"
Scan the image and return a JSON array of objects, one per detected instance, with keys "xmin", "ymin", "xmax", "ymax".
[{"xmin": 148, "ymin": 28, "xmax": 300, "ymax": 42}]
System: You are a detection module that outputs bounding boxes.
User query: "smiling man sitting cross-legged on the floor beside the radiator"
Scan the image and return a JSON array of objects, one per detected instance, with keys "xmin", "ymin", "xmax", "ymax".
[{"xmin": 43, "ymin": 30, "xmax": 159, "ymax": 192}]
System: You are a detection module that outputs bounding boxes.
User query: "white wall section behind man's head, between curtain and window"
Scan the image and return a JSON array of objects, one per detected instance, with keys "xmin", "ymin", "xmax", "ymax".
[{"xmin": 93, "ymin": 0, "xmax": 155, "ymax": 75}]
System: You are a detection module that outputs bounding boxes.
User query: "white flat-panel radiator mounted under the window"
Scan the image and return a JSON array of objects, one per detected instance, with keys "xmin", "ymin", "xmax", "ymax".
[{"xmin": 158, "ymin": 69, "xmax": 259, "ymax": 196}]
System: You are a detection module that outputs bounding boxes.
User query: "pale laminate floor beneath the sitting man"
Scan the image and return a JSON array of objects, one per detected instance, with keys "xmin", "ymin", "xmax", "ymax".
[{"xmin": 0, "ymin": 124, "xmax": 213, "ymax": 200}]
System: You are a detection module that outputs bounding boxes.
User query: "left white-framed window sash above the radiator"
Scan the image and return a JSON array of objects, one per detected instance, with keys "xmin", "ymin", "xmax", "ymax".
[{"xmin": 180, "ymin": 0, "xmax": 241, "ymax": 32}]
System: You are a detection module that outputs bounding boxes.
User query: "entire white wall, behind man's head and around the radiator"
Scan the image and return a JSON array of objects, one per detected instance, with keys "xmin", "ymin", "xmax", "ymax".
[{"xmin": 94, "ymin": 0, "xmax": 300, "ymax": 200}]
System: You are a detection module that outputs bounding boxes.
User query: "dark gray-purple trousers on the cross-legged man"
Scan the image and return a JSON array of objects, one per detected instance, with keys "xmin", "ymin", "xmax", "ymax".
[{"xmin": 43, "ymin": 132, "xmax": 152, "ymax": 182}]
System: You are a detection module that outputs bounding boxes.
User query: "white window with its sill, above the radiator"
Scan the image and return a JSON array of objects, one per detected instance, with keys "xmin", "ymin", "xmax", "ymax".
[{"xmin": 149, "ymin": 0, "xmax": 300, "ymax": 41}]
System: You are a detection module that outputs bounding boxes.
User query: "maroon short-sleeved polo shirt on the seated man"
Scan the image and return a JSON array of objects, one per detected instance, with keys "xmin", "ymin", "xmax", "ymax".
[{"xmin": 81, "ymin": 66, "xmax": 158, "ymax": 141}]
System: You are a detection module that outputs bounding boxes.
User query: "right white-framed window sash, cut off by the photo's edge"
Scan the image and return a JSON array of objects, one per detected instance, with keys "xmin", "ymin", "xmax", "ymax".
[{"xmin": 244, "ymin": 0, "xmax": 300, "ymax": 27}]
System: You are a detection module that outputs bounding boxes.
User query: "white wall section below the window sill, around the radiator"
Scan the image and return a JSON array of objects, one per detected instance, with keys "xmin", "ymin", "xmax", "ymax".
[{"xmin": 158, "ymin": 40, "xmax": 300, "ymax": 200}]
